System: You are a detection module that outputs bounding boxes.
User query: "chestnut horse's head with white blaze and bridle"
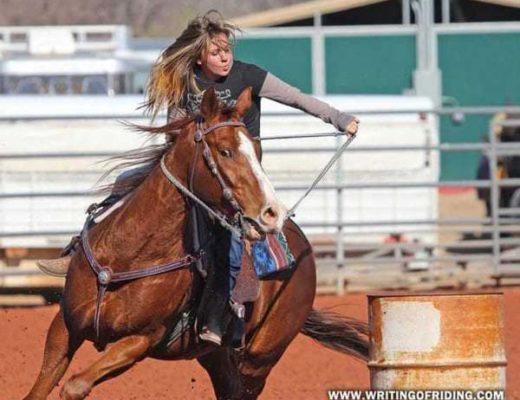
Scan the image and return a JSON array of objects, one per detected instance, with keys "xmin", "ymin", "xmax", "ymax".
[{"xmin": 167, "ymin": 88, "xmax": 287, "ymax": 239}]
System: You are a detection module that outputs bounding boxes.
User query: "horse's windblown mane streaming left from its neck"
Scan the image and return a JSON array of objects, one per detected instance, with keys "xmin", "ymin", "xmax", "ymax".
[{"xmin": 97, "ymin": 107, "xmax": 234, "ymax": 195}]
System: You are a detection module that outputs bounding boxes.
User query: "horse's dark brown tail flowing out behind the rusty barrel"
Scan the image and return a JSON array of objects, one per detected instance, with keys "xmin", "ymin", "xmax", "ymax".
[{"xmin": 300, "ymin": 309, "xmax": 368, "ymax": 361}]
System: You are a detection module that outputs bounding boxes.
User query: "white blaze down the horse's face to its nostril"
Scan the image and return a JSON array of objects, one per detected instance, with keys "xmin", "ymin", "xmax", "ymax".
[{"xmin": 238, "ymin": 130, "xmax": 287, "ymax": 231}]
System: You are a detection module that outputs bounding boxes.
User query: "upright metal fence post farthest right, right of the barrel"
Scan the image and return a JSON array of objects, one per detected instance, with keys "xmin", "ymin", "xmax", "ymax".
[{"xmin": 488, "ymin": 121, "xmax": 500, "ymax": 274}]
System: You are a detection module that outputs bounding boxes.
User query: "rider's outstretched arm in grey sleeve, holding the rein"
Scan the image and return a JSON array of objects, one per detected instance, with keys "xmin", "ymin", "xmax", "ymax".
[{"xmin": 259, "ymin": 72, "xmax": 358, "ymax": 134}]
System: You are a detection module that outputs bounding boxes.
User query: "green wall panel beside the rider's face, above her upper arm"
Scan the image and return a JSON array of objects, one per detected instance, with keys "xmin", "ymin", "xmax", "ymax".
[{"xmin": 235, "ymin": 37, "xmax": 312, "ymax": 93}]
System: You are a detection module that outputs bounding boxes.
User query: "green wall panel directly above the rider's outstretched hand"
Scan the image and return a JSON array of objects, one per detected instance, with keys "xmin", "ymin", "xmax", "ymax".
[{"xmin": 325, "ymin": 35, "xmax": 416, "ymax": 94}]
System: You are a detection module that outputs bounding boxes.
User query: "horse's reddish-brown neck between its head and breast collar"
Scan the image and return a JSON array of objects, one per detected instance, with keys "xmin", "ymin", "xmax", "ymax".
[{"xmin": 93, "ymin": 164, "xmax": 188, "ymax": 267}]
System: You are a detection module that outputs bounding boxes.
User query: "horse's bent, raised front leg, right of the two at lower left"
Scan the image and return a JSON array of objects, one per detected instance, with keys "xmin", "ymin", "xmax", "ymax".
[{"xmin": 61, "ymin": 336, "xmax": 150, "ymax": 400}]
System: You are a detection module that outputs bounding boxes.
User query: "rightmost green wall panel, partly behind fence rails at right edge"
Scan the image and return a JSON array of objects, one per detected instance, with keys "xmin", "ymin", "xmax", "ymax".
[{"xmin": 438, "ymin": 33, "xmax": 520, "ymax": 180}]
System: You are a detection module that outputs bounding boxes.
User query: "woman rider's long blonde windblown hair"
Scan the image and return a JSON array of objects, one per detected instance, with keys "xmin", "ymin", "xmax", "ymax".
[{"xmin": 143, "ymin": 10, "xmax": 239, "ymax": 119}]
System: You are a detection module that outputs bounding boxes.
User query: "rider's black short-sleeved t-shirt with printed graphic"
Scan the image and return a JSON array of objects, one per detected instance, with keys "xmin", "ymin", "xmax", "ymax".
[{"xmin": 183, "ymin": 60, "xmax": 267, "ymax": 137}]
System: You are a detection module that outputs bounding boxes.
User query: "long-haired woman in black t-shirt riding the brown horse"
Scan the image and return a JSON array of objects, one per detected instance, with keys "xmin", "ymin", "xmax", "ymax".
[{"xmin": 39, "ymin": 11, "xmax": 359, "ymax": 344}]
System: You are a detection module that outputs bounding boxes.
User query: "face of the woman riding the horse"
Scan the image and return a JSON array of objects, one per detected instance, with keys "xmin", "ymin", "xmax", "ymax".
[{"xmin": 197, "ymin": 33, "xmax": 233, "ymax": 80}]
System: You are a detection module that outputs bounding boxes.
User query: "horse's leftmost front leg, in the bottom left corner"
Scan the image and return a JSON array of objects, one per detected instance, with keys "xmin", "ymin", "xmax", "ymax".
[{"xmin": 25, "ymin": 310, "xmax": 83, "ymax": 400}]
